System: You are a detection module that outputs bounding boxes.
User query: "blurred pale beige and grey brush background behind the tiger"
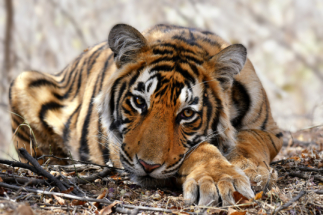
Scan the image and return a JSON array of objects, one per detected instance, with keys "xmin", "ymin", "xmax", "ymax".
[{"xmin": 0, "ymin": 0, "xmax": 323, "ymax": 157}]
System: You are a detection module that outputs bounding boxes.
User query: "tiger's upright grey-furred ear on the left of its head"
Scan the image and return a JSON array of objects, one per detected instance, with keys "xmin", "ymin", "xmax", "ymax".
[{"xmin": 108, "ymin": 24, "xmax": 147, "ymax": 68}]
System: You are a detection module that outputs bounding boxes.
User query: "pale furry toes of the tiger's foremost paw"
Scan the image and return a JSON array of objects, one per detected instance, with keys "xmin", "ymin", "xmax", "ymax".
[{"xmin": 183, "ymin": 165, "xmax": 254, "ymax": 206}]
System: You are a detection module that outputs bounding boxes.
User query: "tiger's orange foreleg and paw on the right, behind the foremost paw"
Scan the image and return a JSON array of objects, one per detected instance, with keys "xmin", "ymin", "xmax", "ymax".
[{"xmin": 226, "ymin": 129, "xmax": 282, "ymax": 188}]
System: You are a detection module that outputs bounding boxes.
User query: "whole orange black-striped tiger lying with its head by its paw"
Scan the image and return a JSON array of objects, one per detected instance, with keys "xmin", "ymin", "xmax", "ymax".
[{"xmin": 9, "ymin": 24, "xmax": 283, "ymax": 205}]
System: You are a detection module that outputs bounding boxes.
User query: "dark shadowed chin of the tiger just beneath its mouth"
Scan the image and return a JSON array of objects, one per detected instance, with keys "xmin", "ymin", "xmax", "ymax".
[{"xmin": 130, "ymin": 174, "xmax": 176, "ymax": 188}]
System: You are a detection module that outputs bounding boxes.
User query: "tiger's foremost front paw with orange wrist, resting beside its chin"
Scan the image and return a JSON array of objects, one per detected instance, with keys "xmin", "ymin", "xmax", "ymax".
[{"xmin": 178, "ymin": 143, "xmax": 254, "ymax": 205}]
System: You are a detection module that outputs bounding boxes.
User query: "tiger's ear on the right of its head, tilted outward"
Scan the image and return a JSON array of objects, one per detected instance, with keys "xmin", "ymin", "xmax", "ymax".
[{"xmin": 211, "ymin": 44, "xmax": 247, "ymax": 90}]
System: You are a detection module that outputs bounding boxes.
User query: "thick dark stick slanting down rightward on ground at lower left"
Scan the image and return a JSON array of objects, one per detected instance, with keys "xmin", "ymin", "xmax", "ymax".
[{"xmin": 18, "ymin": 148, "xmax": 68, "ymax": 191}]
